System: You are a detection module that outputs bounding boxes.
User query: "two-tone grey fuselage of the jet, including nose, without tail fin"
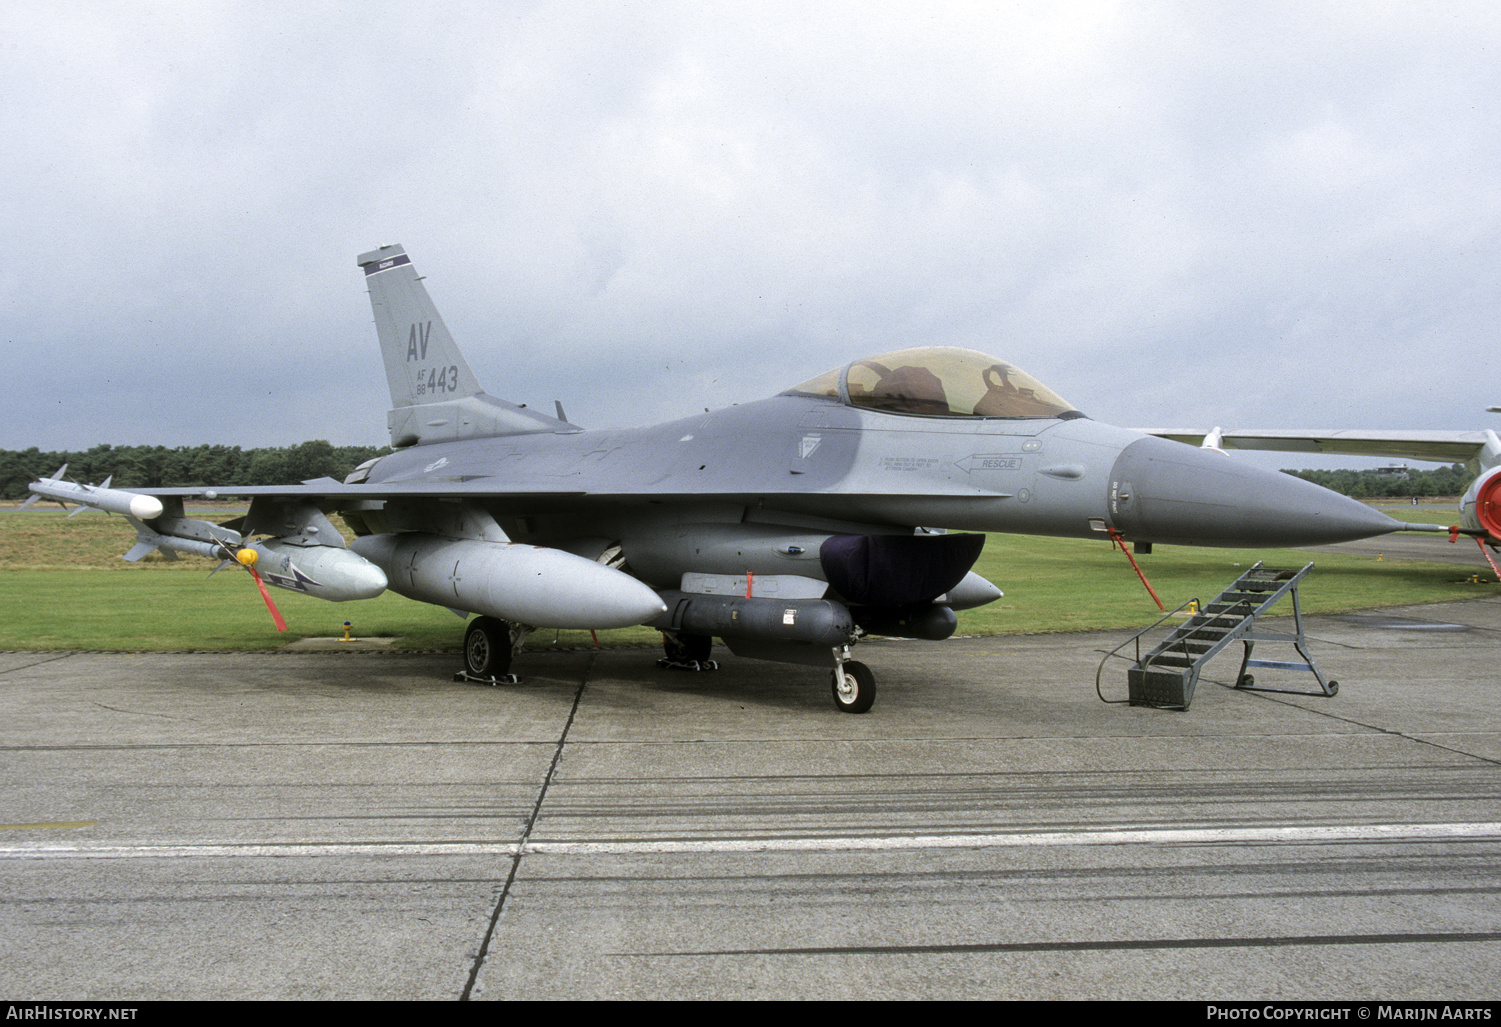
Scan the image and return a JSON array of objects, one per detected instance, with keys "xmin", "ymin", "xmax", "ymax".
[{"xmin": 357, "ymin": 395, "xmax": 1393, "ymax": 586}]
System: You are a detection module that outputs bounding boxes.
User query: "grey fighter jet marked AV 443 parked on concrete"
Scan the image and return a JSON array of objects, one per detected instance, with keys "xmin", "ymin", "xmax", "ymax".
[{"xmin": 30, "ymin": 246, "xmax": 1405, "ymax": 713}]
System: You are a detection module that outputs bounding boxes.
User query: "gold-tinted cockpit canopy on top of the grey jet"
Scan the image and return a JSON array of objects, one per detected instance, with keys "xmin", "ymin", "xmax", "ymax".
[{"xmin": 784, "ymin": 345, "xmax": 1084, "ymax": 419}]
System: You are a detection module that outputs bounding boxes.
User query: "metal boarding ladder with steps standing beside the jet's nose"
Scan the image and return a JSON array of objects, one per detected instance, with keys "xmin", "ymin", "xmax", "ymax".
[{"xmin": 1094, "ymin": 562, "xmax": 1339, "ymax": 710}]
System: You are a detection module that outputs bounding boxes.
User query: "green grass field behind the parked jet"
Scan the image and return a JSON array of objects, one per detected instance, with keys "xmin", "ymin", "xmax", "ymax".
[{"xmin": 0, "ymin": 506, "xmax": 1501, "ymax": 650}]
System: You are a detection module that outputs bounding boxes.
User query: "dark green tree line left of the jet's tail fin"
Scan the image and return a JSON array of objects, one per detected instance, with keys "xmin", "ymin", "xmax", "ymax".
[{"xmin": 0, "ymin": 438, "xmax": 390, "ymax": 500}]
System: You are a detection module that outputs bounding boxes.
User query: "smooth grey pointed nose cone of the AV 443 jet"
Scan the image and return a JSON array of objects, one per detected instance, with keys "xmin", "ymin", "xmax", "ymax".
[{"xmin": 1106, "ymin": 438, "xmax": 1405, "ymax": 547}]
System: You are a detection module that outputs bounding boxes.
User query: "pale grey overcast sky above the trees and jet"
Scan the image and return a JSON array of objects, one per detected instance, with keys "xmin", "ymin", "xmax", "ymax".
[{"xmin": 0, "ymin": 0, "xmax": 1501, "ymax": 465}]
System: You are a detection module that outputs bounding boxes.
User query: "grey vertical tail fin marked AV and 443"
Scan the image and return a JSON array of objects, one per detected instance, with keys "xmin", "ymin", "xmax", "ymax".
[{"xmin": 359, "ymin": 246, "xmax": 576, "ymax": 446}]
